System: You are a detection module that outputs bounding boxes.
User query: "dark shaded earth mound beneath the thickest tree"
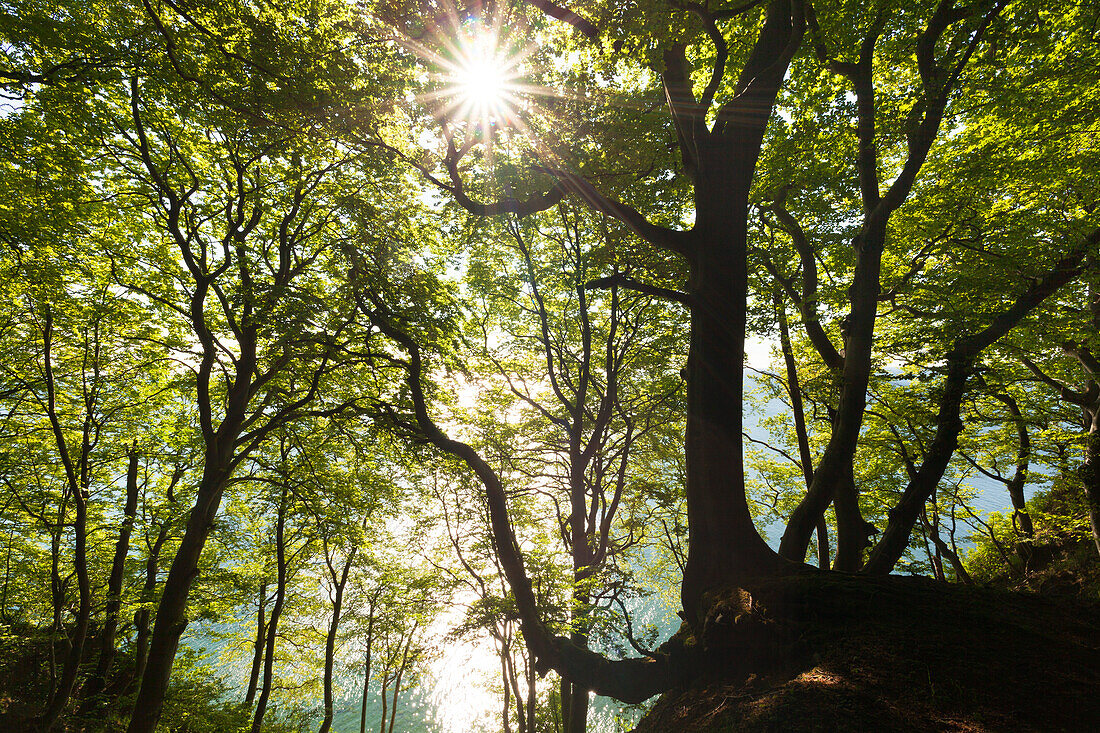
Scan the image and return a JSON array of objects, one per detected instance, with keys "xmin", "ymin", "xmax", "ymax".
[{"xmin": 636, "ymin": 573, "xmax": 1100, "ymax": 733}]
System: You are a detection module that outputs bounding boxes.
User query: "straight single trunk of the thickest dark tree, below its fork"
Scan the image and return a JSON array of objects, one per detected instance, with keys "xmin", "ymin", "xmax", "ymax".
[{"xmin": 681, "ymin": 169, "xmax": 780, "ymax": 626}]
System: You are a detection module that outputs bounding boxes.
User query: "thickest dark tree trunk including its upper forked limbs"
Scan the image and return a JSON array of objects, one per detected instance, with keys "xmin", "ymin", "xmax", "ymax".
[{"xmin": 666, "ymin": 0, "xmax": 804, "ymax": 626}]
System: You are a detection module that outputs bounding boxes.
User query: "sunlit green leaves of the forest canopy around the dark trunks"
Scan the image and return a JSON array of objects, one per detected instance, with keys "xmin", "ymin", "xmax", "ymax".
[{"xmin": 0, "ymin": 0, "xmax": 1100, "ymax": 732}]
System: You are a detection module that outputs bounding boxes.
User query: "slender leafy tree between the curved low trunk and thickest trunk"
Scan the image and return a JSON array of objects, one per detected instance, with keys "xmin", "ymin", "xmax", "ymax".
[{"xmin": 457, "ymin": 204, "xmax": 683, "ymax": 731}]
